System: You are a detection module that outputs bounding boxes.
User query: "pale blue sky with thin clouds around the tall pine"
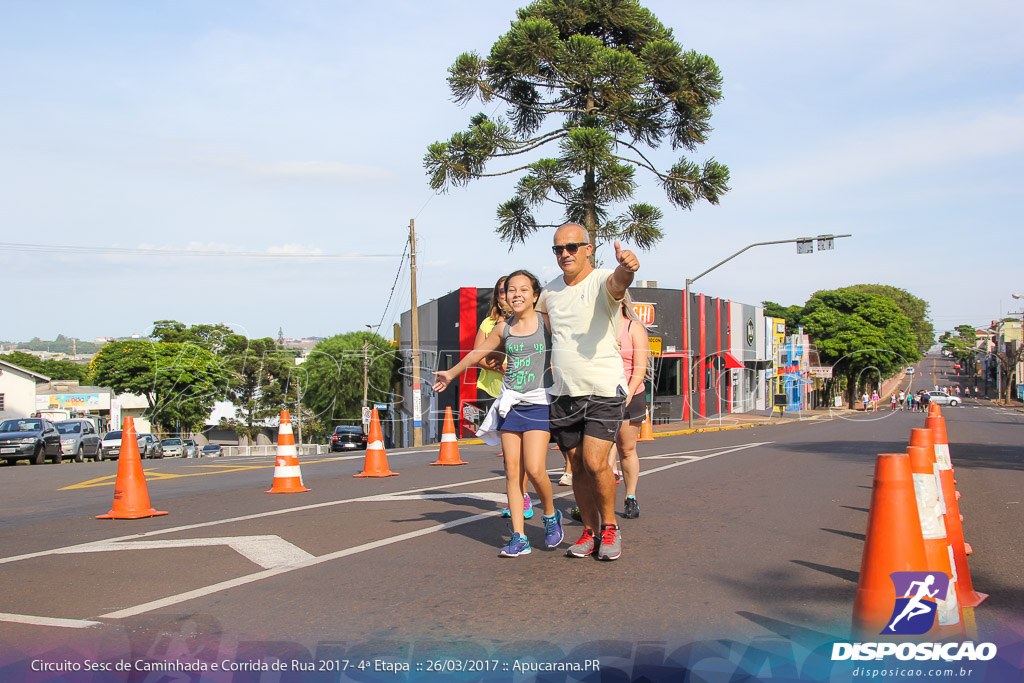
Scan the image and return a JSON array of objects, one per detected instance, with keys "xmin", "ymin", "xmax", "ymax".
[{"xmin": 0, "ymin": 0, "xmax": 1024, "ymax": 340}]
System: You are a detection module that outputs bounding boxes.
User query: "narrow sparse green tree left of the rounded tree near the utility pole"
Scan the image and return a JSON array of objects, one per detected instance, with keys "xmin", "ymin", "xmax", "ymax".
[{"xmin": 221, "ymin": 335, "xmax": 295, "ymax": 440}]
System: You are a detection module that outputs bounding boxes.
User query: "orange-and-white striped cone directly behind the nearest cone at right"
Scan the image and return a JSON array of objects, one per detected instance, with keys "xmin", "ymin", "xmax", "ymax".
[{"xmin": 906, "ymin": 429, "xmax": 967, "ymax": 639}]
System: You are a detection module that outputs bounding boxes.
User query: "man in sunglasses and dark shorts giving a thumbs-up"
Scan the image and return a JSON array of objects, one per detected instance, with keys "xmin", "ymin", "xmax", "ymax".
[{"xmin": 537, "ymin": 223, "xmax": 640, "ymax": 560}]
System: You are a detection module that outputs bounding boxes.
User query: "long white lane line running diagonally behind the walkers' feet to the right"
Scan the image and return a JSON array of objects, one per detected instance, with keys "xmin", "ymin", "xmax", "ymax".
[{"xmin": 97, "ymin": 441, "xmax": 772, "ymax": 620}]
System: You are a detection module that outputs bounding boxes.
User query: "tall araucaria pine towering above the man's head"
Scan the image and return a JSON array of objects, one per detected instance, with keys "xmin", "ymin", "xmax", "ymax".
[{"xmin": 424, "ymin": 0, "xmax": 729, "ymax": 249}]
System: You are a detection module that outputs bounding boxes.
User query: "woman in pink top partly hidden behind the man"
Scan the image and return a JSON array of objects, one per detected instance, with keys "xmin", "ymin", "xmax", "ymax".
[{"xmin": 615, "ymin": 292, "xmax": 650, "ymax": 519}]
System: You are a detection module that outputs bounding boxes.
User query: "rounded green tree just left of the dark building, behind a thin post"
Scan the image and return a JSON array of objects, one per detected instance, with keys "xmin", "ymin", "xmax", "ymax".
[{"xmin": 301, "ymin": 332, "xmax": 399, "ymax": 425}]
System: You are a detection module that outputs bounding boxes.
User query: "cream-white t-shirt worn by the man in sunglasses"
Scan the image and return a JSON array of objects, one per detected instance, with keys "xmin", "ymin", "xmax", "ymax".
[{"xmin": 537, "ymin": 268, "xmax": 627, "ymax": 396}]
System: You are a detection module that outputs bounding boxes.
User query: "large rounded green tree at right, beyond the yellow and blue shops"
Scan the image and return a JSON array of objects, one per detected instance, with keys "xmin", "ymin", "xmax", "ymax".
[{"xmin": 803, "ymin": 288, "xmax": 922, "ymax": 405}]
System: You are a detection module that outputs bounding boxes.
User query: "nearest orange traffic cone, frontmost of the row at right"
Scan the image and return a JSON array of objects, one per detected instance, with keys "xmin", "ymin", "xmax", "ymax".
[{"xmin": 853, "ymin": 453, "xmax": 928, "ymax": 639}]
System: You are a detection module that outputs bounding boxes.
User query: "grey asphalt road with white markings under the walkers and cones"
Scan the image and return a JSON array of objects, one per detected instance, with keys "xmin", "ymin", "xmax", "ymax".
[{"xmin": 0, "ymin": 358, "xmax": 1024, "ymax": 681}]
